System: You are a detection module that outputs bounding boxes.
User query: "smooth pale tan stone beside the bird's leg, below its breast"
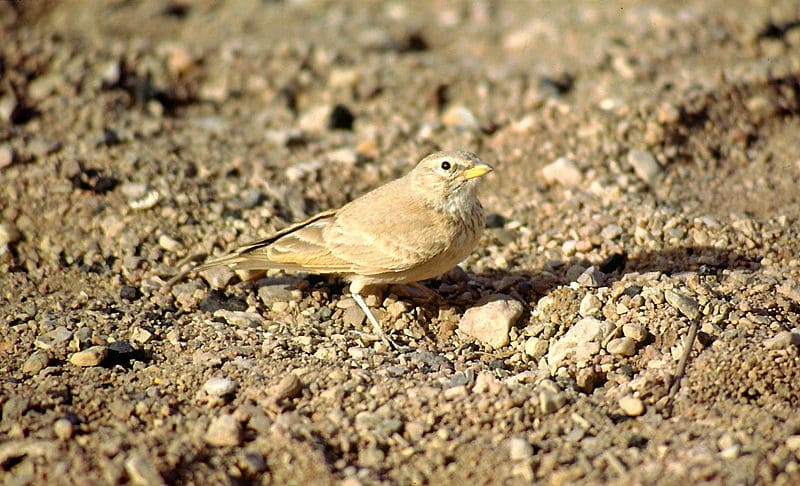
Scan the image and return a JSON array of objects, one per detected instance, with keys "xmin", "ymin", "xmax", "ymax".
[{"xmin": 458, "ymin": 294, "xmax": 523, "ymax": 349}]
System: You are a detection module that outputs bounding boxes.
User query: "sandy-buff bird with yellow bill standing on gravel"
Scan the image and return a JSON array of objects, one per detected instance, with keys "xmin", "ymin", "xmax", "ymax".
[{"xmin": 196, "ymin": 150, "xmax": 493, "ymax": 348}]
